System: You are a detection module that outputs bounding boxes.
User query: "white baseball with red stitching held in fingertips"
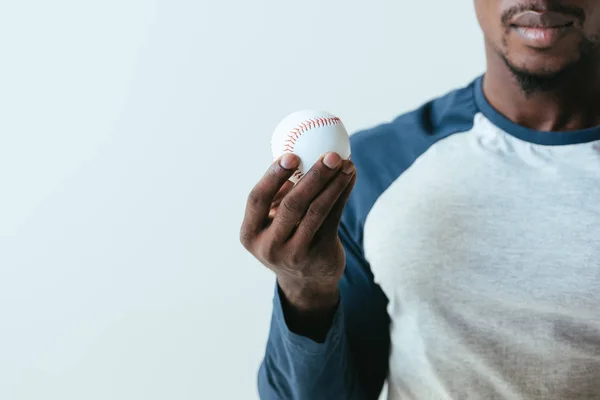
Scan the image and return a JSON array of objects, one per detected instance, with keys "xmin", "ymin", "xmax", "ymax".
[{"xmin": 271, "ymin": 110, "xmax": 350, "ymax": 183}]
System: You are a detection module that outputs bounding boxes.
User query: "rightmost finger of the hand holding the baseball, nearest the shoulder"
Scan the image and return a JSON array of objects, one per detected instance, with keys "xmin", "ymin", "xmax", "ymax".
[{"xmin": 292, "ymin": 161, "xmax": 356, "ymax": 244}]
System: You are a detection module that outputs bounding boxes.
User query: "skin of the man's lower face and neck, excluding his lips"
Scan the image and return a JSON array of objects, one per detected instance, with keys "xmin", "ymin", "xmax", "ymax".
[{"xmin": 475, "ymin": 0, "xmax": 600, "ymax": 131}]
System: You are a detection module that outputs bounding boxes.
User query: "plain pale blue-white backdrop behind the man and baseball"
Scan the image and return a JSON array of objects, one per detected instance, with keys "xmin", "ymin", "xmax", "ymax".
[{"xmin": 0, "ymin": 0, "xmax": 484, "ymax": 400}]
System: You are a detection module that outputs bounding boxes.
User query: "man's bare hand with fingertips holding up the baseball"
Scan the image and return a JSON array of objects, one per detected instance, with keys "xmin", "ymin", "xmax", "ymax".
[{"xmin": 240, "ymin": 153, "xmax": 356, "ymax": 312}]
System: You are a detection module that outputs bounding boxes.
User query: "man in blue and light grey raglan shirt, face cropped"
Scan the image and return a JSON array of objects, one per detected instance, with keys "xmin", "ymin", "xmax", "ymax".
[{"xmin": 241, "ymin": 0, "xmax": 600, "ymax": 400}]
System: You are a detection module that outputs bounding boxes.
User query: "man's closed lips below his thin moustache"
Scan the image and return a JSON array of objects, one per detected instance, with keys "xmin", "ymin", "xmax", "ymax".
[{"xmin": 510, "ymin": 11, "xmax": 577, "ymax": 49}]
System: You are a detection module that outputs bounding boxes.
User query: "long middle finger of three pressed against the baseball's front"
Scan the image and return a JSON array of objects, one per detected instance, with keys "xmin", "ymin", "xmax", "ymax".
[{"xmin": 269, "ymin": 153, "xmax": 342, "ymax": 243}]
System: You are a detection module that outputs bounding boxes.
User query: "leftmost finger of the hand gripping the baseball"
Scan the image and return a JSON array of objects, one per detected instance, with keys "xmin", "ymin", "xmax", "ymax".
[{"xmin": 240, "ymin": 154, "xmax": 300, "ymax": 248}]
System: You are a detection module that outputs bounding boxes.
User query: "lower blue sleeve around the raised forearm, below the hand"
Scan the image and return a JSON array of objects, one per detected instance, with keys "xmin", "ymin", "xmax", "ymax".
[{"xmin": 258, "ymin": 220, "xmax": 389, "ymax": 400}]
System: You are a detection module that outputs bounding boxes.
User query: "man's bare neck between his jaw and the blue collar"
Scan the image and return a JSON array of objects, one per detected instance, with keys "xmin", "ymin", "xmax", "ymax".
[{"xmin": 483, "ymin": 49, "xmax": 600, "ymax": 131}]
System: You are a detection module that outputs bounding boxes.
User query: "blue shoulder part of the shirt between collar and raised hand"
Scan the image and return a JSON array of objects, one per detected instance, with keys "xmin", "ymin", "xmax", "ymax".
[{"xmin": 342, "ymin": 77, "xmax": 478, "ymax": 243}]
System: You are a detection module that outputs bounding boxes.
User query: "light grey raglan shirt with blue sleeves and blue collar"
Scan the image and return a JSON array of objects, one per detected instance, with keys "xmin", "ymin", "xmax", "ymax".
[{"xmin": 258, "ymin": 78, "xmax": 600, "ymax": 400}]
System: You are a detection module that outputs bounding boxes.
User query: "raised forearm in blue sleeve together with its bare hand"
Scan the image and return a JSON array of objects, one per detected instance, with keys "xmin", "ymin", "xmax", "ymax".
[{"xmin": 240, "ymin": 153, "xmax": 389, "ymax": 400}]
